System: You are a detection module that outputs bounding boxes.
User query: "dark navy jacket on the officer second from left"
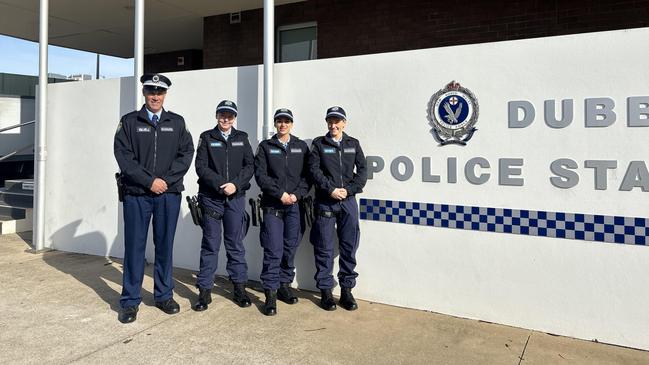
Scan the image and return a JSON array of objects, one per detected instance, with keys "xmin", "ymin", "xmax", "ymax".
[{"xmin": 196, "ymin": 127, "xmax": 254, "ymax": 199}]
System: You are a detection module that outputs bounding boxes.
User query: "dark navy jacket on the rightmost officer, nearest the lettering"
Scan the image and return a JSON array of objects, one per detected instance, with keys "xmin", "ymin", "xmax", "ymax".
[{"xmin": 309, "ymin": 132, "xmax": 367, "ymax": 202}]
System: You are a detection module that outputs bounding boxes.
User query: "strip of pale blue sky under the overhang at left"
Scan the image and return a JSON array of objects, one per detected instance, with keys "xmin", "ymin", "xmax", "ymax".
[{"xmin": 0, "ymin": 35, "xmax": 133, "ymax": 79}]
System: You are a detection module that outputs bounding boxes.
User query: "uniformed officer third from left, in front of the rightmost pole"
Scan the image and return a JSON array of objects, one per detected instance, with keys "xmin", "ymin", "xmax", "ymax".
[{"xmin": 255, "ymin": 108, "xmax": 309, "ymax": 316}]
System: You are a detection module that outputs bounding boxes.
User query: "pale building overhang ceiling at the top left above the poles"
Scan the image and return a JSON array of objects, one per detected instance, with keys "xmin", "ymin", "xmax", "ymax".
[{"xmin": 0, "ymin": 0, "xmax": 305, "ymax": 58}]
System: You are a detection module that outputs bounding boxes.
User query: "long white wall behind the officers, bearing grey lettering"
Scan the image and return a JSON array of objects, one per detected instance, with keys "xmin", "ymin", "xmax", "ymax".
[{"xmin": 46, "ymin": 28, "xmax": 649, "ymax": 349}]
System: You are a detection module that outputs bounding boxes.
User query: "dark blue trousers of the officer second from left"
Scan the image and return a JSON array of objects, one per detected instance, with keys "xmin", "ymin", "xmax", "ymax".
[{"xmin": 196, "ymin": 195, "xmax": 248, "ymax": 289}]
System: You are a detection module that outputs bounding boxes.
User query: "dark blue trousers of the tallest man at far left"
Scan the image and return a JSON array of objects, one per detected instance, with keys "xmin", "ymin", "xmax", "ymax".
[{"xmin": 119, "ymin": 193, "xmax": 180, "ymax": 308}]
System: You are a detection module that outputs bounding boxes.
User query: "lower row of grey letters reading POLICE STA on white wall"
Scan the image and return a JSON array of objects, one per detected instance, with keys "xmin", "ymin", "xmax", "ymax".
[{"xmin": 366, "ymin": 156, "xmax": 649, "ymax": 192}]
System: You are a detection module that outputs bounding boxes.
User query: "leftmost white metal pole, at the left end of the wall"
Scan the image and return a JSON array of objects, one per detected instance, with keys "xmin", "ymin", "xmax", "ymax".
[{"xmin": 32, "ymin": 0, "xmax": 49, "ymax": 250}]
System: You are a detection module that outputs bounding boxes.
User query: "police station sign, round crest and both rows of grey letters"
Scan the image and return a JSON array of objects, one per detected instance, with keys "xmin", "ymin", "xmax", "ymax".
[{"xmin": 367, "ymin": 88, "xmax": 649, "ymax": 192}]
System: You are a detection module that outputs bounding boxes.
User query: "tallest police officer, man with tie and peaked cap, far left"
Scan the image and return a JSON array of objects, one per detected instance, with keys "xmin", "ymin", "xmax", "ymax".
[{"xmin": 114, "ymin": 74, "xmax": 194, "ymax": 323}]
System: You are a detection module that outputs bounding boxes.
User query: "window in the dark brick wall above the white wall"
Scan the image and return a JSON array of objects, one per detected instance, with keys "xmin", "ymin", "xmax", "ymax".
[{"xmin": 276, "ymin": 22, "xmax": 318, "ymax": 62}]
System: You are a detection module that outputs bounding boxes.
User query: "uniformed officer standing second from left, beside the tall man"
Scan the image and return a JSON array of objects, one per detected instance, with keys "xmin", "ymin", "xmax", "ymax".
[{"xmin": 194, "ymin": 100, "xmax": 254, "ymax": 311}]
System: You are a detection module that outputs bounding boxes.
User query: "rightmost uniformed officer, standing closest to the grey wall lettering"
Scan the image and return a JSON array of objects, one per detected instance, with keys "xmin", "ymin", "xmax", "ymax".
[{"xmin": 309, "ymin": 106, "xmax": 367, "ymax": 310}]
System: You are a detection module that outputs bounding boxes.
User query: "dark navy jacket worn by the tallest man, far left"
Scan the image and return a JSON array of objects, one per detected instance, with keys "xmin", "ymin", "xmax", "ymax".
[{"xmin": 113, "ymin": 107, "xmax": 194, "ymax": 195}]
